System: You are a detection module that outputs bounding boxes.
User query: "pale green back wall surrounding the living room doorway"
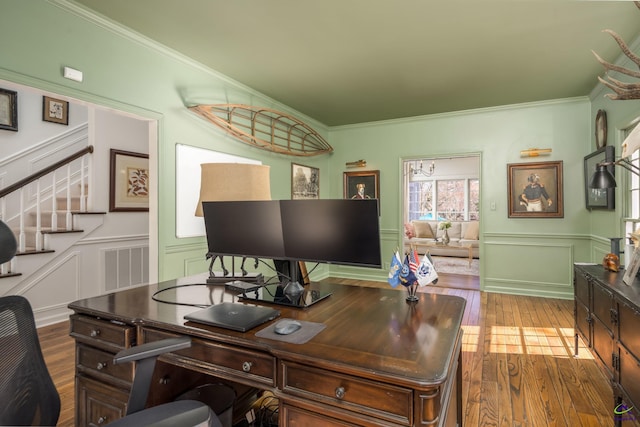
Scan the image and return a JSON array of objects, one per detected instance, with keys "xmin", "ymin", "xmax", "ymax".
[{"xmin": 330, "ymin": 98, "xmax": 590, "ymax": 297}]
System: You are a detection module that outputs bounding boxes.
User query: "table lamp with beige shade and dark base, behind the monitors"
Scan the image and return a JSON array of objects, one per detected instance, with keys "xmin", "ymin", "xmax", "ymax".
[{"xmin": 195, "ymin": 163, "xmax": 271, "ymax": 283}]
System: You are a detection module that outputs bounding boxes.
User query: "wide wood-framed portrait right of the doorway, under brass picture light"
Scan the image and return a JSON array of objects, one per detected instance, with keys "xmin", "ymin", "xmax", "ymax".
[{"xmin": 507, "ymin": 161, "xmax": 564, "ymax": 218}]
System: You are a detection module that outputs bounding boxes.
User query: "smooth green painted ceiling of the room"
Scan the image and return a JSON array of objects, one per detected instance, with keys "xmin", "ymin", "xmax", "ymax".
[{"xmin": 71, "ymin": 0, "xmax": 640, "ymax": 126}]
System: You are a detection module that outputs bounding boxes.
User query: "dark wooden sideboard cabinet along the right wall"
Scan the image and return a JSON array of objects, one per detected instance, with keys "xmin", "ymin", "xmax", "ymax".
[{"xmin": 574, "ymin": 264, "xmax": 640, "ymax": 426}]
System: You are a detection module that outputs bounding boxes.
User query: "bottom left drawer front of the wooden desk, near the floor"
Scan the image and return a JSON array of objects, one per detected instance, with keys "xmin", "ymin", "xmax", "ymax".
[{"xmin": 76, "ymin": 375, "xmax": 129, "ymax": 427}]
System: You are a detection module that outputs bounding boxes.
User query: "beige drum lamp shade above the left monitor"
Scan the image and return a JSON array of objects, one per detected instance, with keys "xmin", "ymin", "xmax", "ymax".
[{"xmin": 196, "ymin": 163, "xmax": 271, "ymax": 216}]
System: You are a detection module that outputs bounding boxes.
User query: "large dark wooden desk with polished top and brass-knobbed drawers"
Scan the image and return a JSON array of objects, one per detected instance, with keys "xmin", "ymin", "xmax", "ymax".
[{"xmin": 69, "ymin": 276, "xmax": 466, "ymax": 426}]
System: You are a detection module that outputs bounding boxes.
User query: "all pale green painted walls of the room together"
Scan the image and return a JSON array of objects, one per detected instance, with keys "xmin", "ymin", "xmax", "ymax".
[{"xmin": 5, "ymin": 0, "xmax": 640, "ymax": 298}]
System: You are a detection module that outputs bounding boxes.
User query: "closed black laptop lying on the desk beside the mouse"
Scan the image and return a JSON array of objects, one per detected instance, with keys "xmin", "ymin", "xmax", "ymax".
[{"xmin": 184, "ymin": 302, "xmax": 280, "ymax": 332}]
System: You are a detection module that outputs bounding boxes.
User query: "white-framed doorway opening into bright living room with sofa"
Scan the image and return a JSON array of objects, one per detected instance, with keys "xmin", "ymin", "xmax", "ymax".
[{"xmin": 402, "ymin": 155, "xmax": 480, "ymax": 289}]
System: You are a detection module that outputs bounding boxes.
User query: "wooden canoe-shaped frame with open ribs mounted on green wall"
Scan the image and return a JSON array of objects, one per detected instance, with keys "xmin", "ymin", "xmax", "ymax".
[{"xmin": 189, "ymin": 104, "xmax": 333, "ymax": 157}]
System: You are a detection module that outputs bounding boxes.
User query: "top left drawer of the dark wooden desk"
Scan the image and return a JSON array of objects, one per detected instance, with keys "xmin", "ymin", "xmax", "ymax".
[{"xmin": 70, "ymin": 314, "xmax": 136, "ymax": 353}]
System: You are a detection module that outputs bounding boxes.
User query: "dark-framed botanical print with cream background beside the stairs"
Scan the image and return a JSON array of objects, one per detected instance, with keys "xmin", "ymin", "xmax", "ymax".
[{"xmin": 109, "ymin": 149, "xmax": 149, "ymax": 212}]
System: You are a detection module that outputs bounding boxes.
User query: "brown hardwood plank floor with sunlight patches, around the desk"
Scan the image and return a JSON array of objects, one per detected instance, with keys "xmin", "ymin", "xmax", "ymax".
[{"xmin": 39, "ymin": 274, "xmax": 640, "ymax": 427}]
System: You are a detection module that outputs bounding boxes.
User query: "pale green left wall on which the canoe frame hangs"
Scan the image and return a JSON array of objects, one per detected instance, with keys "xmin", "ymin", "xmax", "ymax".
[{"xmin": 0, "ymin": 0, "xmax": 329, "ymax": 279}]
